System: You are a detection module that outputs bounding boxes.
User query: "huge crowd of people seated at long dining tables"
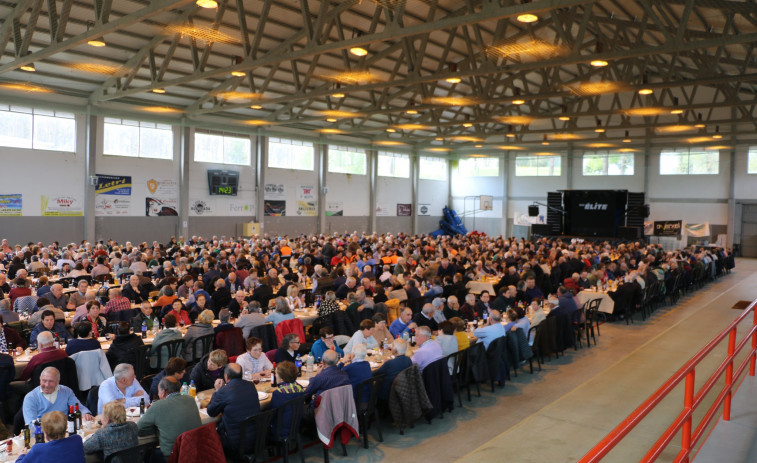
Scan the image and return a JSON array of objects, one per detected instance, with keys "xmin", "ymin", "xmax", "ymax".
[{"xmin": 0, "ymin": 234, "xmax": 734, "ymax": 461}]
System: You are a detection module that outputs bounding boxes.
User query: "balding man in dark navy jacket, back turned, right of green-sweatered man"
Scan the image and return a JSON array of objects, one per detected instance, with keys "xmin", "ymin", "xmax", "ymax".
[{"xmin": 208, "ymin": 363, "xmax": 260, "ymax": 452}]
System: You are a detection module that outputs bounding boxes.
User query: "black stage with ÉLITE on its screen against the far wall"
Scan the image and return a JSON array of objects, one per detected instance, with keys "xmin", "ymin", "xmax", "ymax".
[{"xmin": 529, "ymin": 190, "xmax": 649, "ymax": 239}]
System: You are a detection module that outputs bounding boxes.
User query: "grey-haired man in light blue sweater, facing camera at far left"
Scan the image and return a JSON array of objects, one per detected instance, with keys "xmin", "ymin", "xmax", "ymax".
[{"xmin": 23, "ymin": 367, "xmax": 92, "ymax": 423}]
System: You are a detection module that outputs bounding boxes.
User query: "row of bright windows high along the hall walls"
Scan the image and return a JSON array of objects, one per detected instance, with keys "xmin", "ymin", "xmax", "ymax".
[{"xmin": 0, "ymin": 105, "xmax": 757, "ymax": 176}]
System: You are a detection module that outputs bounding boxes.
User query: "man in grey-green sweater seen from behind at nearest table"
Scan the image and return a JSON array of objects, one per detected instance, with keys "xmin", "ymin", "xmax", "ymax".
[{"xmin": 137, "ymin": 376, "xmax": 202, "ymax": 461}]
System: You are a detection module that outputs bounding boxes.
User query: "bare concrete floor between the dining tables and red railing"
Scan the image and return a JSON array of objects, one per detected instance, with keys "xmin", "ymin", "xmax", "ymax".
[{"xmin": 295, "ymin": 259, "xmax": 757, "ymax": 463}]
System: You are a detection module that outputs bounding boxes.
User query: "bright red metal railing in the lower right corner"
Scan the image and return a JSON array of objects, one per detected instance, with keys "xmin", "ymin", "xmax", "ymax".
[{"xmin": 579, "ymin": 300, "xmax": 757, "ymax": 463}]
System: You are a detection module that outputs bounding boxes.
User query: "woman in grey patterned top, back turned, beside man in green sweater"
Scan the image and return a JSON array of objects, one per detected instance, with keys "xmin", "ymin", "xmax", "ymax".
[{"xmin": 84, "ymin": 400, "xmax": 139, "ymax": 459}]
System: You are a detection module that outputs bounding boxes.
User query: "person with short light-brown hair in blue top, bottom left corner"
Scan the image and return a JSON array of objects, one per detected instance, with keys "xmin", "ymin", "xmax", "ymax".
[{"xmin": 16, "ymin": 411, "xmax": 84, "ymax": 463}]
